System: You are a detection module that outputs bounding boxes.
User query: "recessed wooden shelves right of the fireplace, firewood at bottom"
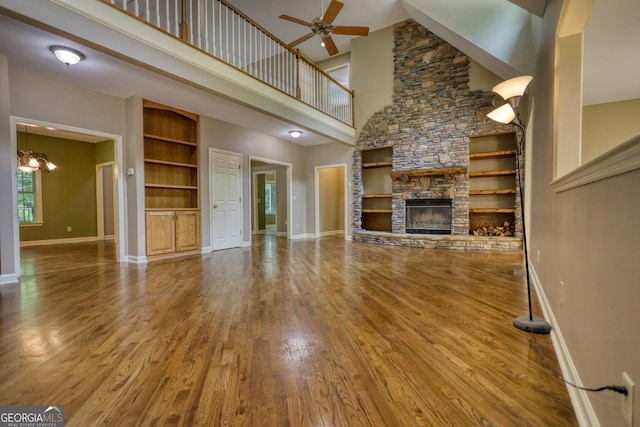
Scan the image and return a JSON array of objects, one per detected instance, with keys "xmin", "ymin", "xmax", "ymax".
[{"xmin": 469, "ymin": 132, "xmax": 517, "ymax": 234}]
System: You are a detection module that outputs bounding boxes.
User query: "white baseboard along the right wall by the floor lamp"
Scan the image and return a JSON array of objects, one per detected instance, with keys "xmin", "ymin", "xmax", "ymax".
[{"xmin": 529, "ymin": 264, "xmax": 600, "ymax": 427}]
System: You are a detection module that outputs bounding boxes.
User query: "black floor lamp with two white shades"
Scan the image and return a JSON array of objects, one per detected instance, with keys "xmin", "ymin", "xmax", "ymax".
[{"xmin": 487, "ymin": 76, "xmax": 551, "ymax": 334}]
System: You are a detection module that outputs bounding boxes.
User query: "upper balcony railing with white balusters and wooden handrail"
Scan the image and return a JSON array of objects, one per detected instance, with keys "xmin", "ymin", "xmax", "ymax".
[{"xmin": 101, "ymin": 0, "xmax": 353, "ymax": 126}]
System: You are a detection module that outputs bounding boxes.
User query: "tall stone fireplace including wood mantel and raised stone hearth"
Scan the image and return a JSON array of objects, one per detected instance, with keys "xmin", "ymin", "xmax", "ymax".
[{"xmin": 353, "ymin": 20, "xmax": 522, "ymax": 250}]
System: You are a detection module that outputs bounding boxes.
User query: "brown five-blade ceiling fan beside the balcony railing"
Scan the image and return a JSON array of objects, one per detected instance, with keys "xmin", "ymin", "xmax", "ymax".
[{"xmin": 280, "ymin": 0, "xmax": 369, "ymax": 56}]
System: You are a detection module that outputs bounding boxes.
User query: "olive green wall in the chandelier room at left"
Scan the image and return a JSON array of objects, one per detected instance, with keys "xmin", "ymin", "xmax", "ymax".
[{"xmin": 18, "ymin": 132, "xmax": 105, "ymax": 241}]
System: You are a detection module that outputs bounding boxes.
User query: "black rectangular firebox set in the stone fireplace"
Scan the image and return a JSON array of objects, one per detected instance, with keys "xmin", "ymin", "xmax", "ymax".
[{"xmin": 405, "ymin": 199, "xmax": 452, "ymax": 234}]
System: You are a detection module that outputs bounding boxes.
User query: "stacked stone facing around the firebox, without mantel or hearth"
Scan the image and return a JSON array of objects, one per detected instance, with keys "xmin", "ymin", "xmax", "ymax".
[{"xmin": 353, "ymin": 20, "xmax": 520, "ymax": 244}]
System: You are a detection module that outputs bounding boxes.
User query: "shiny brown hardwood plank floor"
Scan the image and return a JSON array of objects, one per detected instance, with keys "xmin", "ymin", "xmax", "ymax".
[{"xmin": 0, "ymin": 237, "xmax": 577, "ymax": 427}]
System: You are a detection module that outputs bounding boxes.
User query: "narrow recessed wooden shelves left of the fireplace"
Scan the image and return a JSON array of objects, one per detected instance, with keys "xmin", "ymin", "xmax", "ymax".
[{"xmin": 362, "ymin": 147, "xmax": 393, "ymax": 232}]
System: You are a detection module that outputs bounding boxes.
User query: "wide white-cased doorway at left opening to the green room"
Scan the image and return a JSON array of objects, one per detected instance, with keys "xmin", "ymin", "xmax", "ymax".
[{"xmin": 11, "ymin": 116, "xmax": 126, "ymax": 272}]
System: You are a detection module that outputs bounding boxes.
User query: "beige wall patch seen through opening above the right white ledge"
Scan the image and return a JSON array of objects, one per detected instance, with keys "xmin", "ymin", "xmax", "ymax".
[{"xmin": 582, "ymin": 99, "xmax": 640, "ymax": 164}]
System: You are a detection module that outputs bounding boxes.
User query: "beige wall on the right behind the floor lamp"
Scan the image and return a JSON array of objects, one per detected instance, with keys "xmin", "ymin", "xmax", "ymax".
[{"xmin": 521, "ymin": 0, "xmax": 640, "ymax": 426}]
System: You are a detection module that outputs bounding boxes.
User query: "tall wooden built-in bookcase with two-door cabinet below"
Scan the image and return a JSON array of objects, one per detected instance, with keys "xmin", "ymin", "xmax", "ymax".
[{"xmin": 143, "ymin": 100, "xmax": 200, "ymax": 256}]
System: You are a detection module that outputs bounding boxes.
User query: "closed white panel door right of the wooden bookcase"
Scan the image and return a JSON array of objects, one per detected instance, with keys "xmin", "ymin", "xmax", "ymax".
[{"xmin": 209, "ymin": 150, "xmax": 242, "ymax": 251}]
